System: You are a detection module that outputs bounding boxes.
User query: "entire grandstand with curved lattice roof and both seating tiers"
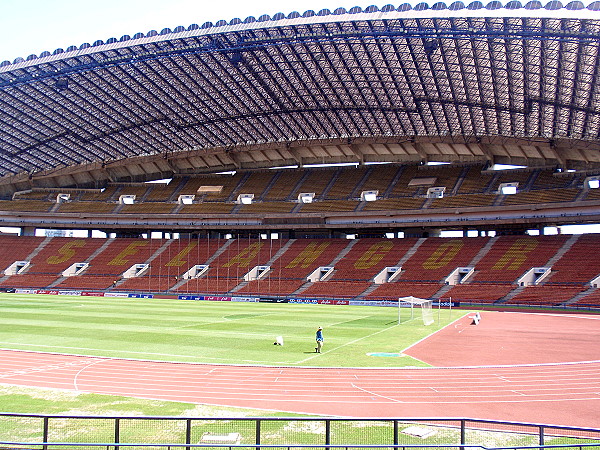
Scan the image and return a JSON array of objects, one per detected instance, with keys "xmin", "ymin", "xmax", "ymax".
[{"xmin": 0, "ymin": 1, "xmax": 600, "ymax": 307}]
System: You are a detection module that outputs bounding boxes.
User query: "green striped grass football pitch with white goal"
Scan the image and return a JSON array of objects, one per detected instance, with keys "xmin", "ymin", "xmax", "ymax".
[{"xmin": 0, "ymin": 294, "xmax": 467, "ymax": 367}]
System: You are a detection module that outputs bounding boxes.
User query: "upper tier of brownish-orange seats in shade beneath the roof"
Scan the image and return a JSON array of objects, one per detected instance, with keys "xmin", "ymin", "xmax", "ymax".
[{"xmin": 0, "ymin": 165, "xmax": 600, "ymax": 214}]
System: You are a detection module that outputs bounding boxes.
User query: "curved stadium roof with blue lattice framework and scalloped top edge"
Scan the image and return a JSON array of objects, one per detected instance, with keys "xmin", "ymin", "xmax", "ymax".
[{"xmin": 0, "ymin": 0, "xmax": 600, "ymax": 185}]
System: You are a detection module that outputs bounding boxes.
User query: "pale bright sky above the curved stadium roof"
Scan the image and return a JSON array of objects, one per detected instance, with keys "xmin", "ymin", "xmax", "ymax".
[{"xmin": 0, "ymin": 0, "xmax": 398, "ymax": 61}]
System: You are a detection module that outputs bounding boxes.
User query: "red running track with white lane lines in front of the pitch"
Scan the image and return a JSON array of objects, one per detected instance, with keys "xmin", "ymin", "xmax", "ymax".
[{"xmin": 0, "ymin": 312, "xmax": 600, "ymax": 427}]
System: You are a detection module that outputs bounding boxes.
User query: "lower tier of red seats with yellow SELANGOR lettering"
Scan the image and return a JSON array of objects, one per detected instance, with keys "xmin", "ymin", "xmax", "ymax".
[{"xmin": 0, "ymin": 230, "xmax": 600, "ymax": 307}]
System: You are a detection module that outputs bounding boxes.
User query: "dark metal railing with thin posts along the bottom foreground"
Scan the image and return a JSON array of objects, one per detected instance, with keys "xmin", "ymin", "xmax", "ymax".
[{"xmin": 0, "ymin": 413, "xmax": 600, "ymax": 450}]
